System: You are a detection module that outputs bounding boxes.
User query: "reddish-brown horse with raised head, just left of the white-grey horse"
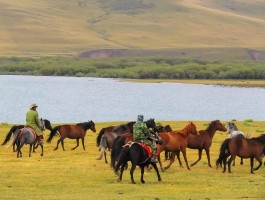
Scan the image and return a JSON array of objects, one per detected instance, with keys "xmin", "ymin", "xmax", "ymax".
[{"xmin": 178, "ymin": 120, "xmax": 227, "ymax": 167}]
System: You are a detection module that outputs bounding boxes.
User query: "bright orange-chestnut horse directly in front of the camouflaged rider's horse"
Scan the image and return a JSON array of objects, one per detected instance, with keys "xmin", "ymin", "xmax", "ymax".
[{"xmin": 156, "ymin": 122, "xmax": 197, "ymax": 171}]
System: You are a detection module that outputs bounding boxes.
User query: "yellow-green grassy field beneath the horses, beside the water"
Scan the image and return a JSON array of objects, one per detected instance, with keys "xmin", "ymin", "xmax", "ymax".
[{"xmin": 0, "ymin": 120, "xmax": 265, "ymax": 200}]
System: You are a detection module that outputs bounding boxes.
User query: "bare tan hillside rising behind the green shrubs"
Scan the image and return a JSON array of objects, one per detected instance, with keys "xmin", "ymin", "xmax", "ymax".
[{"xmin": 0, "ymin": 0, "xmax": 265, "ymax": 60}]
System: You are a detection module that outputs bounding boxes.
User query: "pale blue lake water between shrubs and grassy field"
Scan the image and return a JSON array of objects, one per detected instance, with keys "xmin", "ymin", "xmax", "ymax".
[{"xmin": 0, "ymin": 75, "xmax": 265, "ymax": 124}]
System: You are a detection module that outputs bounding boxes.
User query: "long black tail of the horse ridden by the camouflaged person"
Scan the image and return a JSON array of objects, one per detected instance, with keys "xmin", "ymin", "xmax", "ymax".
[{"xmin": 110, "ymin": 136, "xmax": 126, "ymax": 169}]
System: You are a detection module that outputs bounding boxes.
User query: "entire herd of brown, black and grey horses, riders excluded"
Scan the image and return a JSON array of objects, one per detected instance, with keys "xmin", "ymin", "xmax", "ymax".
[{"xmin": 2, "ymin": 119, "xmax": 265, "ymax": 183}]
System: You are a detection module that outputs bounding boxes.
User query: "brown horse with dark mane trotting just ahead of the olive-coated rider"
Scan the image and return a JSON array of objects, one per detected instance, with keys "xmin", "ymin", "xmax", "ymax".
[{"xmin": 47, "ymin": 120, "xmax": 96, "ymax": 151}]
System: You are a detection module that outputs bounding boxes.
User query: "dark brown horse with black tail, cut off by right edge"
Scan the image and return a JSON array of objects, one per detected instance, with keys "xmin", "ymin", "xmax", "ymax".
[{"xmin": 216, "ymin": 134, "xmax": 265, "ymax": 174}]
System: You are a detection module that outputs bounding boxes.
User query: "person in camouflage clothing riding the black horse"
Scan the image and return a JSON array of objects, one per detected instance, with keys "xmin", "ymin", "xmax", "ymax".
[{"xmin": 133, "ymin": 115, "xmax": 158, "ymax": 163}]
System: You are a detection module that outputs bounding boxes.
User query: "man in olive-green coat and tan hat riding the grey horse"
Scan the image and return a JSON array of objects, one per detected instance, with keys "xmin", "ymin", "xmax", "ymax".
[{"xmin": 26, "ymin": 103, "xmax": 43, "ymax": 144}]
